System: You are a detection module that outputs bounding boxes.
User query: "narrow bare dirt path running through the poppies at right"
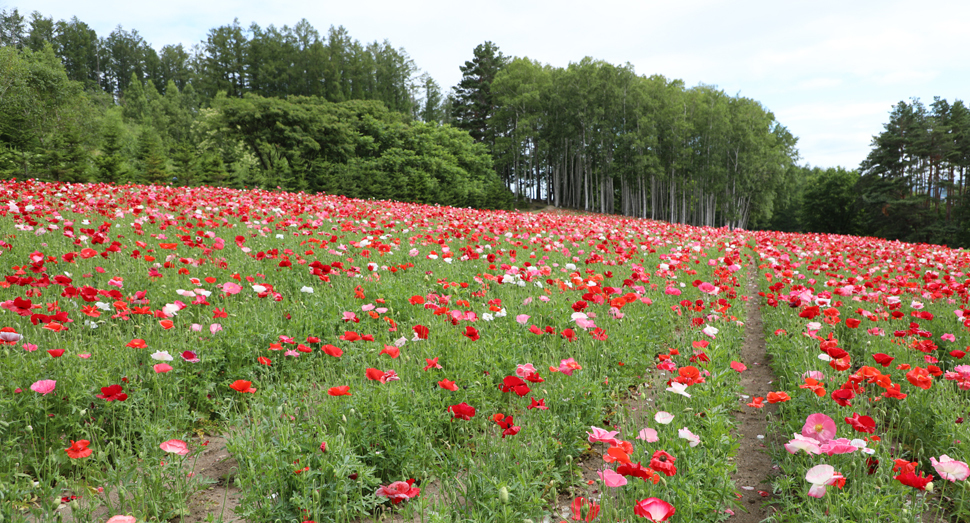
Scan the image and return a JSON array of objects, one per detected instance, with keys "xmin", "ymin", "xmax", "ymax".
[{"xmin": 730, "ymin": 258, "xmax": 777, "ymax": 523}]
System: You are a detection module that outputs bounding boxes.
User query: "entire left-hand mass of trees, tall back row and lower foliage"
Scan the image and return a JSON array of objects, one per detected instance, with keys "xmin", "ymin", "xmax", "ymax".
[{"xmin": 0, "ymin": 10, "xmax": 511, "ymax": 208}]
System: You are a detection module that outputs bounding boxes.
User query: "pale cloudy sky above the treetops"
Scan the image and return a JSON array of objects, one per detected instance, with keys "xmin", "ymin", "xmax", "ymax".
[{"xmin": 13, "ymin": 0, "xmax": 970, "ymax": 169}]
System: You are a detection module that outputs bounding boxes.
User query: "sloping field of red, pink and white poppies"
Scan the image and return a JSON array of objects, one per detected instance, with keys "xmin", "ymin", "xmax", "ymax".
[{"xmin": 0, "ymin": 180, "xmax": 970, "ymax": 523}]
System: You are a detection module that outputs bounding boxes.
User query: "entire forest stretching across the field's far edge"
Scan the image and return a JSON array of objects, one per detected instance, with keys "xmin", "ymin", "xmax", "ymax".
[{"xmin": 0, "ymin": 9, "xmax": 970, "ymax": 245}]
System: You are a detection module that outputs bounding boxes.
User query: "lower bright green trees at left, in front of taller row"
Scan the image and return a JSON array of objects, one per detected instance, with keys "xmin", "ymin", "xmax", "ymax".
[{"xmin": 0, "ymin": 45, "xmax": 511, "ymax": 208}]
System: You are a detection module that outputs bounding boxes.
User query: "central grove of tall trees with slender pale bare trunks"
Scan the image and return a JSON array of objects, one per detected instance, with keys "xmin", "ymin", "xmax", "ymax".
[{"xmin": 451, "ymin": 42, "xmax": 797, "ymax": 227}]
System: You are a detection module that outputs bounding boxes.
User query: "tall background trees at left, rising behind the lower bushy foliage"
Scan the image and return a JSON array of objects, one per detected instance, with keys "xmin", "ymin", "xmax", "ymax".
[{"xmin": 0, "ymin": 9, "xmax": 444, "ymax": 117}]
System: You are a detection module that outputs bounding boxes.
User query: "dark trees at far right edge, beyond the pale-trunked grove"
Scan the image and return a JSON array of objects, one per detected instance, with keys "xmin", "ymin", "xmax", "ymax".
[{"xmin": 768, "ymin": 97, "xmax": 970, "ymax": 247}]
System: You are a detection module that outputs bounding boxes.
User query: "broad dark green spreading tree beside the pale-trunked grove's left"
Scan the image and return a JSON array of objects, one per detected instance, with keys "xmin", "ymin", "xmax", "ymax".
[{"xmin": 207, "ymin": 95, "xmax": 508, "ymax": 207}]
